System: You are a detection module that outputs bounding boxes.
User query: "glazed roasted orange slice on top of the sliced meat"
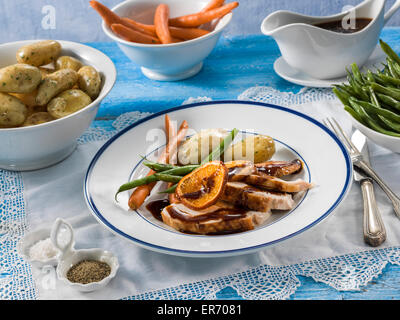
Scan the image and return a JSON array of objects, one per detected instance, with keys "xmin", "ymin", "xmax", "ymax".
[{"xmin": 175, "ymin": 161, "xmax": 228, "ymax": 210}]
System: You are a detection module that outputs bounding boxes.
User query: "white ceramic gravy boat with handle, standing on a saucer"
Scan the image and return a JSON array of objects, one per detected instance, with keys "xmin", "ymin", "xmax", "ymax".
[{"xmin": 261, "ymin": 0, "xmax": 400, "ymax": 79}]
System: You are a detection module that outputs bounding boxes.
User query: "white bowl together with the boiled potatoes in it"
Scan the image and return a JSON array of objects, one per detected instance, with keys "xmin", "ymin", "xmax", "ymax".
[{"xmin": 0, "ymin": 40, "xmax": 117, "ymax": 171}]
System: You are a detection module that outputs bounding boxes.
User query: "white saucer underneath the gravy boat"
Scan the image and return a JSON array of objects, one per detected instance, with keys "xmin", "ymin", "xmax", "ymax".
[{"xmin": 274, "ymin": 45, "xmax": 386, "ymax": 88}]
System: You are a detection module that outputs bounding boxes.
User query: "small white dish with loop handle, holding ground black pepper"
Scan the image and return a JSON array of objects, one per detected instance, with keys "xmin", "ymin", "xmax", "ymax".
[{"xmin": 50, "ymin": 218, "xmax": 119, "ymax": 292}]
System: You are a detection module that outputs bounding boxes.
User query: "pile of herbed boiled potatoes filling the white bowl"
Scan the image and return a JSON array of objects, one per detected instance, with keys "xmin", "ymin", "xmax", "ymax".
[{"xmin": 0, "ymin": 40, "xmax": 102, "ymax": 128}]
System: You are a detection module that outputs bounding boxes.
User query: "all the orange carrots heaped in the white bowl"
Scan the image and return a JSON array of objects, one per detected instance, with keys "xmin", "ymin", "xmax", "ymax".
[{"xmin": 90, "ymin": 0, "xmax": 239, "ymax": 44}]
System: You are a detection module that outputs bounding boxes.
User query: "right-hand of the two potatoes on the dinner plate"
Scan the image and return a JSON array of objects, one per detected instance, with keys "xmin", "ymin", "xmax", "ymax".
[{"xmin": 224, "ymin": 135, "xmax": 275, "ymax": 163}]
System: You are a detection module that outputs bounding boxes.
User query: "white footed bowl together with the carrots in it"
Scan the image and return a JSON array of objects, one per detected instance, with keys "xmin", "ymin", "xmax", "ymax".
[{"xmin": 90, "ymin": 0, "xmax": 239, "ymax": 81}]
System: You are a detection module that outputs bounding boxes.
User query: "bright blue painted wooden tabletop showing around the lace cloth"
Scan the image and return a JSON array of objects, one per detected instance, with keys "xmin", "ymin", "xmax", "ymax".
[{"xmin": 90, "ymin": 28, "xmax": 400, "ymax": 300}]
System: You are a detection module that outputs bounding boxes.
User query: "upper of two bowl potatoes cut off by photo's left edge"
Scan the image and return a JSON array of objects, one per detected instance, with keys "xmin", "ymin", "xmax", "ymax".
[{"xmin": 0, "ymin": 63, "xmax": 42, "ymax": 93}]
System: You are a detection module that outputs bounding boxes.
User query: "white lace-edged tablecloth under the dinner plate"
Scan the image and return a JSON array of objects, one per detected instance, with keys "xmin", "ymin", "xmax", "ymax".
[{"xmin": 0, "ymin": 87, "xmax": 400, "ymax": 299}]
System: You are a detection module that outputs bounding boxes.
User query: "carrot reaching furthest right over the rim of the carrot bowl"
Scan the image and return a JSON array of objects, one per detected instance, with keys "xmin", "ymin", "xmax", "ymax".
[{"xmin": 169, "ymin": 1, "xmax": 239, "ymax": 28}]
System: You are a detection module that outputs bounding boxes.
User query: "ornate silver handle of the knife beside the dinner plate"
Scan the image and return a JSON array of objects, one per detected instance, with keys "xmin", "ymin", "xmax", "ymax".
[{"xmin": 361, "ymin": 178, "xmax": 386, "ymax": 247}]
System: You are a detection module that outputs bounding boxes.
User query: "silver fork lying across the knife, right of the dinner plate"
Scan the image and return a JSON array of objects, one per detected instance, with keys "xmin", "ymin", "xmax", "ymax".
[{"xmin": 324, "ymin": 118, "xmax": 400, "ymax": 218}]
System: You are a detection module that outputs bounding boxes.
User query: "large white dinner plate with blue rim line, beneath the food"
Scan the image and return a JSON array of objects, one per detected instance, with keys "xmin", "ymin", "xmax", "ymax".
[{"xmin": 84, "ymin": 101, "xmax": 352, "ymax": 257}]
